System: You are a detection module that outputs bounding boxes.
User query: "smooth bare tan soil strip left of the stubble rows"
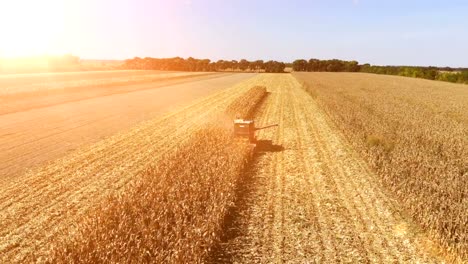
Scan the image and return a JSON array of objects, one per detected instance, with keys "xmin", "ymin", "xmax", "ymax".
[{"xmin": 0, "ymin": 71, "xmax": 253, "ymax": 179}]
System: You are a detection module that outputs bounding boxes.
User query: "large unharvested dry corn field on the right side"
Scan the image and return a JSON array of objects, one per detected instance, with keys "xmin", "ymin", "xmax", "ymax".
[{"xmin": 296, "ymin": 73, "xmax": 468, "ymax": 259}]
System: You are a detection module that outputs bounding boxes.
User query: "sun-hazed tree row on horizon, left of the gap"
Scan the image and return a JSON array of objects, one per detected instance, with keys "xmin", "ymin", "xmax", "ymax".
[{"xmin": 123, "ymin": 57, "xmax": 286, "ymax": 73}]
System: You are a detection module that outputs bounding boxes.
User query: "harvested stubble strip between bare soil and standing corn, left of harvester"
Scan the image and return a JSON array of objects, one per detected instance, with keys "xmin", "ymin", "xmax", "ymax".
[{"xmin": 0, "ymin": 73, "xmax": 267, "ymax": 262}]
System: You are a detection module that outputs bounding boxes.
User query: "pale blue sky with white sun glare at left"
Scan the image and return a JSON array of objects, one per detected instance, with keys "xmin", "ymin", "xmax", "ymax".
[{"xmin": 0, "ymin": 0, "xmax": 468, "ymax": 67}]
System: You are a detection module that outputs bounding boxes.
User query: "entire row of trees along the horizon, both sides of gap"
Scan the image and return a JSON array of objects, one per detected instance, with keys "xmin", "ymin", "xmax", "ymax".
[{"xmin": 123, "ymin": 57, "xmax": 468, "ymax": 84}]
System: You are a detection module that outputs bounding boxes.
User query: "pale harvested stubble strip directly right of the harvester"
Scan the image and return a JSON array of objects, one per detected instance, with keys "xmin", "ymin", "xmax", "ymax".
[{"xmin": 213, "ymin": 75, "xmax": 450, "ymax": 263}]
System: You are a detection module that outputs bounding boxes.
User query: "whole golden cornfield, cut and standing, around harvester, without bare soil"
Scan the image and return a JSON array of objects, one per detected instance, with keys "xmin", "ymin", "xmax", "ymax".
[{"xmin": 0, "ymin": 73, "xmax": 460, "ymax": 263}]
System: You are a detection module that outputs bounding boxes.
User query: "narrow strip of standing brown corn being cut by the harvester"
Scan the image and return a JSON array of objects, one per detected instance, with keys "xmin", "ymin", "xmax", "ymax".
[{"xmin": 47, "ymin": 87, "xmax": 266, "ymax": 263}]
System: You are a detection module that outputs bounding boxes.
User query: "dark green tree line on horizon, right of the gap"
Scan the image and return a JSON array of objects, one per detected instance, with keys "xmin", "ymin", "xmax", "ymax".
[{"xmin": 292, "ymin": 59, "xmax": 468, "ymax": 84}]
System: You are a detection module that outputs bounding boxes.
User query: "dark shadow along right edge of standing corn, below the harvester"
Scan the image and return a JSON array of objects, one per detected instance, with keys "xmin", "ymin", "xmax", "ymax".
[{"xmin": 208, "ymin": 140, "xmax": 284, "ymax": 263}]
